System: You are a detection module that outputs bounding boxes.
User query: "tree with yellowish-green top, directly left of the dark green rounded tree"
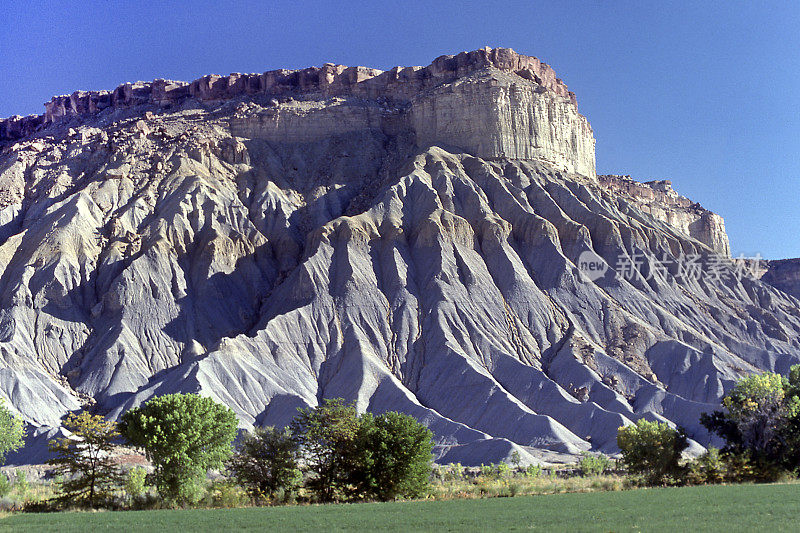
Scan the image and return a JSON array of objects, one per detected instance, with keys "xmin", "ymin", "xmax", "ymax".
[{"xmin": 291, "ymin": 398, "xmax": 359, "ymax": 502}]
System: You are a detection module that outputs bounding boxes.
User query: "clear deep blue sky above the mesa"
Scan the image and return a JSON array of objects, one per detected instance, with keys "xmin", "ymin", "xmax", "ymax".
[{"xmin": 0, "ymin": 0, "xmax": 800, "ymax": 258}]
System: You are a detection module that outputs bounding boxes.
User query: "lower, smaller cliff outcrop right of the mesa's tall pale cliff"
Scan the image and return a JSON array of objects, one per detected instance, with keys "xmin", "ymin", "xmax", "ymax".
[{"xmin": 598, "ymin": 175, "xmax": 730, "ymax": 257}]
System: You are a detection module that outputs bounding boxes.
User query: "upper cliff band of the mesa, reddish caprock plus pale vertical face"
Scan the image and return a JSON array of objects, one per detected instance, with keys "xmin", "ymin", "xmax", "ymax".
[{"xmin": 0, "ymin": 48, "xmax": 595, "ymax": 176}]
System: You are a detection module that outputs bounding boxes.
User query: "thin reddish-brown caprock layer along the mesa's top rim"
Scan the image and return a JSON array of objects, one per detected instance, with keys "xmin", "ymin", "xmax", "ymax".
[{"xmin": 0, "ymin": 47, "xmax": 577, "ymax": 143}]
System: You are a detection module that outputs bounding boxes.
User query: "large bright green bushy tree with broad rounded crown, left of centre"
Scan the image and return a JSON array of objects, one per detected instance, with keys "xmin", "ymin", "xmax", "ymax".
[{"xmin": 120, "ymin": 394, "xmax": 238, "ymax": 502}]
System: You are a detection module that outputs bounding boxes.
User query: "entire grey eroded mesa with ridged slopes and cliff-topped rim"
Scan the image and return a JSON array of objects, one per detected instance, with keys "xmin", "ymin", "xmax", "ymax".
[{"xmin": 0, "ymin": 49, "xmax": 800, "ymax": 464}]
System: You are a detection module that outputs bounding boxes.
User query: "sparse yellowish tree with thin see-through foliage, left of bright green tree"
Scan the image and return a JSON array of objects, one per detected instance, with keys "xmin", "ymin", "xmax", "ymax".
[{"xmin": 48, "ymin": 411, "xmax": 120, "ymax": 507}]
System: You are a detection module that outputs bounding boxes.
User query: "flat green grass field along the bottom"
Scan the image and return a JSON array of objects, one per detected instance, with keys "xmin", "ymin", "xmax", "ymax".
[{"xmin": 0, "ymin": 484, "xmax": 800, "ymax": 533}]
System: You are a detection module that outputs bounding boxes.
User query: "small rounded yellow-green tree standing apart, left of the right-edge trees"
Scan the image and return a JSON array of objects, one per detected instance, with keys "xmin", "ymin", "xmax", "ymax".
[{"xmin": 617, "ymin": 419, "xmax": 689, "ymax": 485}]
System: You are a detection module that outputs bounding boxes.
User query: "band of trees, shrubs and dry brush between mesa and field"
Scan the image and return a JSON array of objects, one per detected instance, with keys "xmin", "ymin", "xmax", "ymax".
[{"xmin": 0, "ymin": 366, "xmax": 800, "ymax": 511}]
